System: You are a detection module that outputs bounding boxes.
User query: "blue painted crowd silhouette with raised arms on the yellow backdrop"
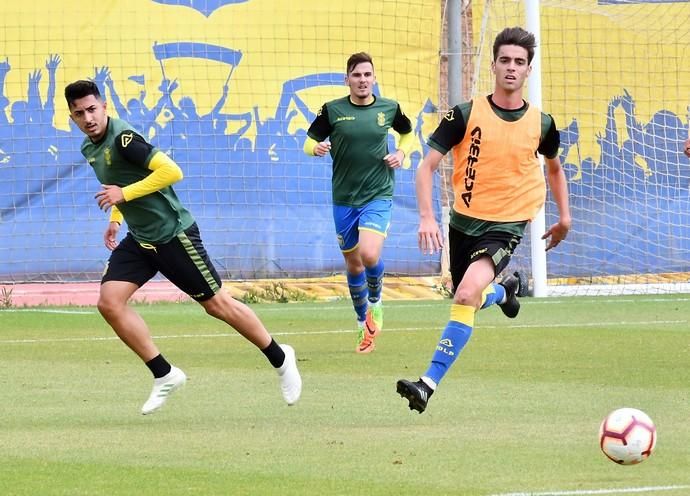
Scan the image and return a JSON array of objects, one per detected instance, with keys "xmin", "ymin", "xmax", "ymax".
[{"xmin": 0, "ymin": 42, "xmax": 690, "ymax": 277}]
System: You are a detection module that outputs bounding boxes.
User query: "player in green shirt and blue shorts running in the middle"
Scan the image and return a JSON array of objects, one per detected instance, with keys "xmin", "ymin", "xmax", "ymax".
[{"xmin": 304, "ymin": 52, "xmax": 414, "ymax": 353}]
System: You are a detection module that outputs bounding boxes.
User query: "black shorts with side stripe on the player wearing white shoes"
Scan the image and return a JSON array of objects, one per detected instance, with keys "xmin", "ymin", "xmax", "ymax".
[{"xmin": 101, "ymin": 223, "xmax": 221, "ymax": 301}]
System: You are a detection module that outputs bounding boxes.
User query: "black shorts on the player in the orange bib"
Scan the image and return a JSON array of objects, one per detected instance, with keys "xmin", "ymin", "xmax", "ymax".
[{"xmin": 448, "ymin": 226, "xmax": 522, "ymax": 292}]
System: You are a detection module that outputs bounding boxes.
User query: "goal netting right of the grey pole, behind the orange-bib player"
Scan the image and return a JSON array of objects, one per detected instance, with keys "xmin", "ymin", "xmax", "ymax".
[{"xmin": 464, "ymin": 0, "xmax": 690, "ymax": 295}]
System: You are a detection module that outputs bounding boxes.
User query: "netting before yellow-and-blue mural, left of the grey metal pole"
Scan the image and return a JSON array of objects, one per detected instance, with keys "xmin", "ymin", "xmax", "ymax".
[{"xmin": 0, "ymin": 0, "xmax": 442, "ymax": 283}]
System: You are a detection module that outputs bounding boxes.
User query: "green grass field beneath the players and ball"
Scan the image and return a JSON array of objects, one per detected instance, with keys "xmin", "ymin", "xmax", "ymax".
[{"xmin": 0, "ymin": 295, "xmax": 690, "ymax": 496}]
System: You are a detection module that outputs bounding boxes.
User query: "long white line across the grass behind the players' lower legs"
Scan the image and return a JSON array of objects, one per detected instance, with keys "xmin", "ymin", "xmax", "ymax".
[{"xmin": 0, "ymin": 320, "xmax": 688, "ymax": 345}]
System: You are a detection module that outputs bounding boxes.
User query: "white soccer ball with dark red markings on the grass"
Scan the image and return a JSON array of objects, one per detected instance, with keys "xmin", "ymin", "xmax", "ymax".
[{"xmin": 599, "ymin": 408, "xmax": 656, "ymax": 465}]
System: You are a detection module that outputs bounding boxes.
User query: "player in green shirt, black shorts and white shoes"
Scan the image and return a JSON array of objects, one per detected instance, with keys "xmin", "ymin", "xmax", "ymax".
[{"xmin": 65, "ymin": 80, "xmax": 302, "ymax": 415}]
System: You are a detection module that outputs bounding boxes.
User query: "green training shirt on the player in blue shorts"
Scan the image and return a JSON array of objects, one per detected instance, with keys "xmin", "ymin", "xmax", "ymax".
[{"xmin": 307, "ymin": 96, "xmax": 412, "ymax": 207}]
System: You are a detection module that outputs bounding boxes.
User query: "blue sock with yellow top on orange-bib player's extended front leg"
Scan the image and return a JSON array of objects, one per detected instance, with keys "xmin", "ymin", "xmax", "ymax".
[{"xmin": 424, "ymin": 304, "xmax": 475, "ymax": 385}]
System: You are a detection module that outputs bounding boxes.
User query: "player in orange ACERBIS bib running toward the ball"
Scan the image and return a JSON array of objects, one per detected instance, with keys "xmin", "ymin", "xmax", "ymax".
[{"xmin": 397, "ymin": 27, "xmax": 571, "ymax": 413}]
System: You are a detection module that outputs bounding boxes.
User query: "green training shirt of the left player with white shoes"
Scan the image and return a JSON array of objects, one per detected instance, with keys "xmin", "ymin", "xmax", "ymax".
[{"xmin": 81, "ymin": 117, "xmax": 194, "ymax": 244}]
